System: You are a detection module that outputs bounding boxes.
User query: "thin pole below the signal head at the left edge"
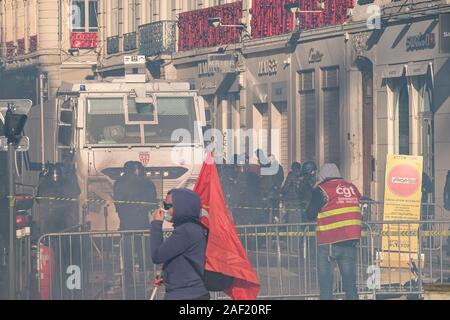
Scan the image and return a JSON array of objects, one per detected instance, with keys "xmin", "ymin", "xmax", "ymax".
[{"xmin": 8, "ymin": 142, "xmax": 16, "ymax": 300}]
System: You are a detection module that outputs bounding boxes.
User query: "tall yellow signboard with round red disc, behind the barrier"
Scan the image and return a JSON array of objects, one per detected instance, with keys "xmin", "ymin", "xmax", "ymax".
[{"xmin": 381, "ymin": 155, "xmax": 423, "ymax": 268}]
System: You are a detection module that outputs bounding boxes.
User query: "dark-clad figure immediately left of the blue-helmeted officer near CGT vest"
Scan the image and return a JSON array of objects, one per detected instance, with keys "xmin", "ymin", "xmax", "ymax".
[{"xmin": 281, "ymin": 162, "xmax": 302, "ymax": 223}]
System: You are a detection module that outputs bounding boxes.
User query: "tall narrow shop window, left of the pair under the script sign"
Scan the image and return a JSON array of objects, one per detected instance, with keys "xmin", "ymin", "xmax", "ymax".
[{"xmin": 299, "ymin": 70, "xmax": 316, "ymax": 162}]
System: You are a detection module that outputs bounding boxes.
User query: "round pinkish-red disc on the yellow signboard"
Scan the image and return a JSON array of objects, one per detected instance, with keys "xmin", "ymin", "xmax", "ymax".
[{"xmin": 388, "ymin": 164, "xmax": 420, "ymax": 197}]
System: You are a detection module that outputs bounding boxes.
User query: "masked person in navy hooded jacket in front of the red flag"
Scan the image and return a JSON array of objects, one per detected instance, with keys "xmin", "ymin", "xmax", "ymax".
[{"xmin": 150, "ymin": 189, "xmax": 209, "ymax": 300}]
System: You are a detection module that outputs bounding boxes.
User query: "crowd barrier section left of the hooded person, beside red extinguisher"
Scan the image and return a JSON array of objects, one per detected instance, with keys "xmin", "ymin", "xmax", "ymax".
[{"xmin": 38, "ymin": 231, "xmax": 165, "ymax": 300}]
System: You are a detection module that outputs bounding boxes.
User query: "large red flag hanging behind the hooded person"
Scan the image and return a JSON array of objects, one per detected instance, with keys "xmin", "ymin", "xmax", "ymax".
[{"xmin": 194, "ymin": 153, "xmax": 260, "ymax": 300}]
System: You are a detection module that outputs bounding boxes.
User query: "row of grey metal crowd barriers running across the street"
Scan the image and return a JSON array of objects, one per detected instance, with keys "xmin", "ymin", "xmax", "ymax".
[{"xmin": 34, "ymin": 220, "xmax": 450, "ymax": 300}]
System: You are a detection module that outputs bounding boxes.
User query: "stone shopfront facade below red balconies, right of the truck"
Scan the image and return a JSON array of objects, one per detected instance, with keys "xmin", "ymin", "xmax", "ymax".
[{"xmin": 173, "ymin": 1, "xmax": 450, "ymax": 215}]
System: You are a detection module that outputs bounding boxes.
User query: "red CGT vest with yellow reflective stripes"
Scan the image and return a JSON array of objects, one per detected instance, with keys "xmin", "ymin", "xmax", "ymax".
[{"xmin": 316, "ymin": 179, "xmax": 362, "ymax": 245}]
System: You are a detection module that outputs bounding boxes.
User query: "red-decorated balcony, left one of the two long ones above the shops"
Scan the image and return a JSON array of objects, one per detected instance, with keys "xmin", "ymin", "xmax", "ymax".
[{"xmin": 178, "ymin": 1, "xmax": 242, "ymax": 51}]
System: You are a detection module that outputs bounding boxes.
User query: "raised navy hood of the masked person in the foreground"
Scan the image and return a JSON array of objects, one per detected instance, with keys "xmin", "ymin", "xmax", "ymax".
[{"xmin": 172, "ymin": 189, "xmax": 201, "ymax": 226}]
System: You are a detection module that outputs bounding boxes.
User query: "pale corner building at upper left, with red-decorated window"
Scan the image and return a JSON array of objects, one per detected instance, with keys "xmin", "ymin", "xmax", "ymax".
[{"xmin": 0, "ymin": 0, "xmax": 98, "ymax": 104}]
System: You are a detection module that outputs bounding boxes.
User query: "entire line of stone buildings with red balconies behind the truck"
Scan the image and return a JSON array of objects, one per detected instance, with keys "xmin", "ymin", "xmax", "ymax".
[{"xmin": 0, "ymin": 0, "xmax": 450, "ymax": 214}]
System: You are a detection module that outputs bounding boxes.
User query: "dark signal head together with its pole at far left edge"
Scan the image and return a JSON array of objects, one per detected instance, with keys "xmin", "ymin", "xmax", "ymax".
[{"xmin": 0, "ymin": 100, "xmax": 33, "ymax": 300}]
